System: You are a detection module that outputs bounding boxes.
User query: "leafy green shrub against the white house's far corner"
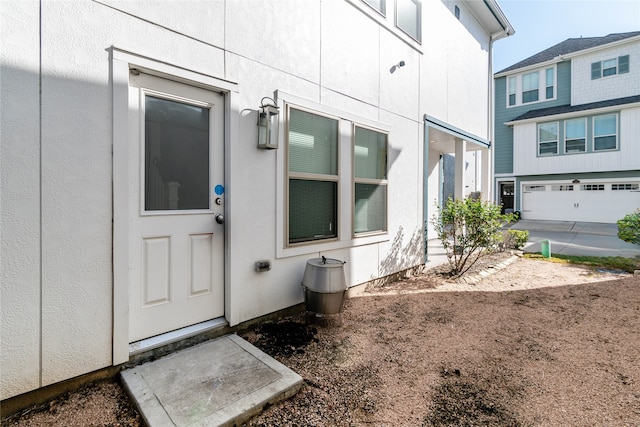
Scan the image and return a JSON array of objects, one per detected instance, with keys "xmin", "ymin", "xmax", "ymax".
[{"xmin": 431, "ymin": 197, "xmax": 513, "ymax": 276}]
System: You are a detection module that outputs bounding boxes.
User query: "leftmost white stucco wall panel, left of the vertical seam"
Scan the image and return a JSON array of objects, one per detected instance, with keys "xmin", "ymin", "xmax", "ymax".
[{"xmin": 0, "ymin": 2, "xmax": 40, "ymax": 399}]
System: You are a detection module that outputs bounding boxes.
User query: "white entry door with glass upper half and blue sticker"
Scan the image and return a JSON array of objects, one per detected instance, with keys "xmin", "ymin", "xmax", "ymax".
[{"xmin": 129, "ymin": 72, "xmax": 224, "ymax": 342}]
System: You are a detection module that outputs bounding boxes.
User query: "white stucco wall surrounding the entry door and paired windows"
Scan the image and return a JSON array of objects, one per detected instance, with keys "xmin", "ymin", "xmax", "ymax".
[{"xmin": 0, "ymin": 0, "xmax": 500, "ymax": 399}]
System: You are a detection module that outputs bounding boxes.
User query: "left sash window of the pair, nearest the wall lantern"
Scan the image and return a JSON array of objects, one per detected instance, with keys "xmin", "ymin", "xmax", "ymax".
[{"xmin": 288, "ymin": 108, "xmax": 339, "ymax": 244}]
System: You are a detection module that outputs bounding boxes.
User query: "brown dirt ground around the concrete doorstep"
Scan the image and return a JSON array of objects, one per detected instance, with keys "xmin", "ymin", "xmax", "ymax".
[{"xmin": 3, "ymin": 255, "xmax": 640, "ymax": 427}]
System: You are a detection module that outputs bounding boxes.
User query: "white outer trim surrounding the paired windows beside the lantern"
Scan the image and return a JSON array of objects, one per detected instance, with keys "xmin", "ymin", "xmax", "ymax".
[{"xmin": 275, "ymin": 91, "xmax": 391, "ymax": 259}]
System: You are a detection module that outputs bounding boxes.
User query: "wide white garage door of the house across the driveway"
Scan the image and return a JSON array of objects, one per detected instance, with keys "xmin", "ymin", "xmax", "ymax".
[{"xmin": 521, "ymin": 181, "xmax": 640, "ymax": 223}]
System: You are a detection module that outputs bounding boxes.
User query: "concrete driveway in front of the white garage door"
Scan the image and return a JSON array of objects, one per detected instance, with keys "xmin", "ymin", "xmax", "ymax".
[{"xmin": 510, "ymin": 219, "xmax": 640, "ymax": 258}]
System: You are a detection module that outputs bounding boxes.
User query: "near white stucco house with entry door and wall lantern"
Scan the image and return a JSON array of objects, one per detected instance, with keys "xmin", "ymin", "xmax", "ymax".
[{"xmin": 0, "ymin": 0, "xmax": 513, "ymax": 399}]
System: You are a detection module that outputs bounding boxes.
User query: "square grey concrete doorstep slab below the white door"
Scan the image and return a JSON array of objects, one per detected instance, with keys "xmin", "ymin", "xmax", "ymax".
[{"xmin": 122, "ymin": 335, "xmax": 302, "ymax": 427}]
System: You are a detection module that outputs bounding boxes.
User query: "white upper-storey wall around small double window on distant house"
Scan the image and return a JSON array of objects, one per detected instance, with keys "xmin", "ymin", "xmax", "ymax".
[{"xmin": 571, "ymin": 40, "xmax": 640, "ymax": 105}]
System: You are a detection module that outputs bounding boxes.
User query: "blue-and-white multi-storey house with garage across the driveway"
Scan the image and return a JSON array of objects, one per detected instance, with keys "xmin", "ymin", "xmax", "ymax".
[{"xmin": 494, "ymin": 31, "xmax": 640, "ymax": 223}]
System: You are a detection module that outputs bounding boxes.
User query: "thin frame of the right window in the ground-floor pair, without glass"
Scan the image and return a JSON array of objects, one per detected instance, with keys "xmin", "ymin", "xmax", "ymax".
[{"xmin": 351, "ymin": 122, "xmax": 389, "ymax": 238}]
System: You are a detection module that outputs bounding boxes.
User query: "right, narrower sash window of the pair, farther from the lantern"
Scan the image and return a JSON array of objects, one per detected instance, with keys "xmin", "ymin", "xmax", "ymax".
[{"xmin": 353, "ymin": 126, "xmax": 387, "ymax": 234}]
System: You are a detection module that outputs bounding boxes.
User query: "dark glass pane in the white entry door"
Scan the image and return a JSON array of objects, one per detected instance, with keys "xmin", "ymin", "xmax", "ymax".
[{"xmin": 144, "ymin": 96, "xmax": 210, "ymax": 211}]
